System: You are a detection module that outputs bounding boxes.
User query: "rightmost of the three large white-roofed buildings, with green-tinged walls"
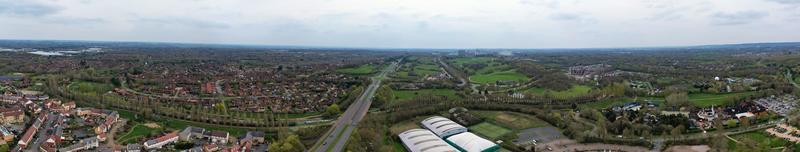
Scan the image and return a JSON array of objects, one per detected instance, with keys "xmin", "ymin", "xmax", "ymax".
[{"xmin": 447, "ymin": 132, "xmax": 500, "ymax": 152}]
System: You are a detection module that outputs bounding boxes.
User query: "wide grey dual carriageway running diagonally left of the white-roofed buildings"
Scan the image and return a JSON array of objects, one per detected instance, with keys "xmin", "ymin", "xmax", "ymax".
[{"xmin": 312, "ymin": 61, "xmax": 399, "ymax": 152}]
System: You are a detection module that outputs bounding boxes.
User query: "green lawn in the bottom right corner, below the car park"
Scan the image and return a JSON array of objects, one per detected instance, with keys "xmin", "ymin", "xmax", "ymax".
[{"xmin": 728, "ymin": 131, "xmax": 789, "ymax": 151}]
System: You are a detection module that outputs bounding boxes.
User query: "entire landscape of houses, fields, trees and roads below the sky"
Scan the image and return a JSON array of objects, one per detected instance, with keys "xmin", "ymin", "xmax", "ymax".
[{"xmin": 0, "ymin": 40, "xmax": 800, "ymax": 152}]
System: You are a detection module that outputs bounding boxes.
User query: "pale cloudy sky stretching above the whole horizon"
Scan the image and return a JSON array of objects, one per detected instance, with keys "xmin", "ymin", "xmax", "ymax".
[{"xmin": 0, "ymin": 0, "xmax": 800, "ymax": 48}]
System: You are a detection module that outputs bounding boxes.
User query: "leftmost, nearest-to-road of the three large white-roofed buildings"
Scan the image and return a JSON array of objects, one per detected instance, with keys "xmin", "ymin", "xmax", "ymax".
[{"xmin": 397, "ymin": 129, "xmax": 458, "ymax": 152}]
